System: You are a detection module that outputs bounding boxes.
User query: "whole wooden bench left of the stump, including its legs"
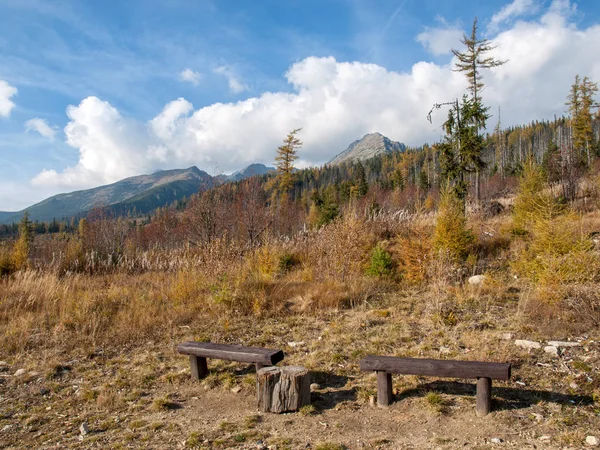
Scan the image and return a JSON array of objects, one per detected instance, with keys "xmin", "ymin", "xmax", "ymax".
[{"xmin": 177, "ymin": 341, "xmax": 284, "ymax": 380}]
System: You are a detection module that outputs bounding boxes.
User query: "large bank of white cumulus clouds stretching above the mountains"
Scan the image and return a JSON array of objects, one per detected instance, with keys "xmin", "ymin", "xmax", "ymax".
[{"xmin": 35, "ymin": 1, "xmax": 600, "ymax": 192}]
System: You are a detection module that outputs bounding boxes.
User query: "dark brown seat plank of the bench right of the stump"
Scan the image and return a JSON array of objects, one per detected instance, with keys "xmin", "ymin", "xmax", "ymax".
[{"xmin": 360, "ymin": 355, "xmax": 511, "ymax": 380}]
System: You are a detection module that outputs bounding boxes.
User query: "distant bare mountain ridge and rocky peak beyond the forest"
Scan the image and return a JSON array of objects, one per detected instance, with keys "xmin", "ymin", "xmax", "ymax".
[{"xmin": 0, "ymin": 133, "xmax": 405, "ymax": 223}]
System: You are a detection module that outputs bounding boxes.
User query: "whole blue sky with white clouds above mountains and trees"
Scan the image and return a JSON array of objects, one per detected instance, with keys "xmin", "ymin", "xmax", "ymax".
[{"xmin": 0, "ymin": 0, "xmax": 600, "ymax": 211}]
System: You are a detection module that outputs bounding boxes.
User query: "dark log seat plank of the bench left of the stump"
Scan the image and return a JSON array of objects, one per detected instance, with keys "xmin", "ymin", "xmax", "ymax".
[{"xmin": 177, "ymin": 341, "xmax": 284, "ymax": 366}]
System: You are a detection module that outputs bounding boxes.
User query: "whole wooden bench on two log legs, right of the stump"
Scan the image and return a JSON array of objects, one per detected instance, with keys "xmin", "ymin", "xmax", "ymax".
[{"xmin": 360, "ymin": 355, "xmax": 511, "ymax": 416}]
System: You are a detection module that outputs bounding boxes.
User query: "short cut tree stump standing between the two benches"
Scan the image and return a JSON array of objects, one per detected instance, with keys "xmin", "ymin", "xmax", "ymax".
[{"xmin": 256, "ymin": 366, "xmax": 310, "ymax": 413}]
